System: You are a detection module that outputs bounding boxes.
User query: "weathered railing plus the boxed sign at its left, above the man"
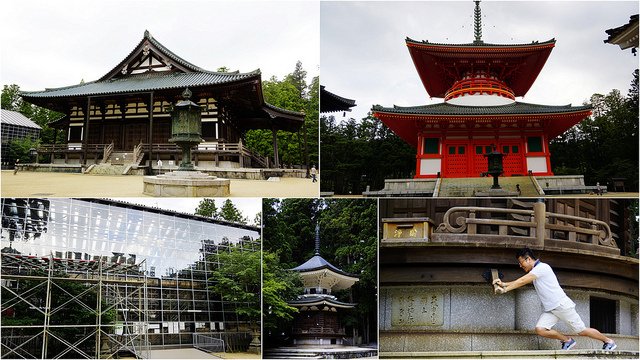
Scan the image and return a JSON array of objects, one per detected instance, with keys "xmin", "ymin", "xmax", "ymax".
[{"xmin": 381, "ymin": 202, "xmax": 620, "ymax": 255}]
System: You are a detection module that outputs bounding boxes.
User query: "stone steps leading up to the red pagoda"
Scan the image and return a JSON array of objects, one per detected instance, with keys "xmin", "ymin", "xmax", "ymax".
[{"xmin": 438, "ymin": 176, "xmax": 540, "ymax": 197}]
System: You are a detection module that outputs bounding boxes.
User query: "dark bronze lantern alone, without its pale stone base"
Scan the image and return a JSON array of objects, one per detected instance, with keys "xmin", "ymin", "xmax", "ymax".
[{"xmin": 169, "ymin": 89, "xmax": 203, "ymax": 171}]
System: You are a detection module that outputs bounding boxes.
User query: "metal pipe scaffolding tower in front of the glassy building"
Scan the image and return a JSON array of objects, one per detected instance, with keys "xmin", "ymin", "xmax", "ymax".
[{"xmin": 0, "ymin": 253, "xmax": 149, "ymax": 359}]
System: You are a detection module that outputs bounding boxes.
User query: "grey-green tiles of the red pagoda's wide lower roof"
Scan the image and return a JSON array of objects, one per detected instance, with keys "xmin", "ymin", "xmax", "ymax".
[{"xmin": 372, "ymin": 102, "xmax": 591, "ymax": 116}]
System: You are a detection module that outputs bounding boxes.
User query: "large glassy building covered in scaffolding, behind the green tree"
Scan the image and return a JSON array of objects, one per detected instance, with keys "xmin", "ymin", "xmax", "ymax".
[{"xmin": 1, "ymin": 198, "xmax": 260, "ymax": 358}]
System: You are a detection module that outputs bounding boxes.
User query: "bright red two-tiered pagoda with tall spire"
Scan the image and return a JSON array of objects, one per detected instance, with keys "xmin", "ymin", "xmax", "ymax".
[{"xmin": 373, "ymin": 1, "xmax": 591, "ymax": 178}]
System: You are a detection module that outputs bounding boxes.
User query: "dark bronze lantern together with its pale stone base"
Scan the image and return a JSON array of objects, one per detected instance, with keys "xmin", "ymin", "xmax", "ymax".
[{"xmin": 143, "ymin": 89, "xmax": 231, "ymax": 197}]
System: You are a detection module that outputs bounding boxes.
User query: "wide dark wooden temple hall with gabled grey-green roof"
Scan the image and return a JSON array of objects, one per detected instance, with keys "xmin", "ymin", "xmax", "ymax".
[{"xmin": 21, "ymin": 31, "xmax": 304, "ymax": 174}]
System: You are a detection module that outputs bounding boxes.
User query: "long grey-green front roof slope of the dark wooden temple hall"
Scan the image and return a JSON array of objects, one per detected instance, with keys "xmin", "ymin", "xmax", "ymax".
[{"xmin": 21, "ymin": 70, "xmax": 260, "ymax": 100}]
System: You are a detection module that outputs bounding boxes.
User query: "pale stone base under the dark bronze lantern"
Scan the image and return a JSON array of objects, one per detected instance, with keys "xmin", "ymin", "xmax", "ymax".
[{"xmin": 143, "ymin": 171, "xmax": 231, "ymax": 197}]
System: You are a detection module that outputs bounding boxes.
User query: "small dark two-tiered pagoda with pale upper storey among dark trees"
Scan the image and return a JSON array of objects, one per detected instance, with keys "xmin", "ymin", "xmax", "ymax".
[{"xmin": 289, "ymin": 226, "xmax": 359, "ymax": 345}]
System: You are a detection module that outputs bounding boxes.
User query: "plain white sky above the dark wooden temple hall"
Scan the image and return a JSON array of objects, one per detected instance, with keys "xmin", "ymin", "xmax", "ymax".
[{"xmin": 0, "ymin": 0, "xmax": 320, "ymax": 90}]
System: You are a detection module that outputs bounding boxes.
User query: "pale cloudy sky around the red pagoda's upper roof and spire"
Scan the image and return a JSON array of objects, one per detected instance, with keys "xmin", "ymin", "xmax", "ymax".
[{"xmin": 320, "ymin": 1, "xmax": 638, "ymax": 119}]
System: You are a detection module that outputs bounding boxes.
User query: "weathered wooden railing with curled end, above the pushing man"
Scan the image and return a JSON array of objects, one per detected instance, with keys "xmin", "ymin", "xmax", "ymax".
[{"xmin": 435, "ymin": 203, "xmax": 618, "ymax": 249}]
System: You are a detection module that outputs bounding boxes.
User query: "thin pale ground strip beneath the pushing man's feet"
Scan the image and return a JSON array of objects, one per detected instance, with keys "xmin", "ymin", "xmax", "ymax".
[{"xmin": 380, "ymin": 350, "xmax": 640, "ymax": 359}]
